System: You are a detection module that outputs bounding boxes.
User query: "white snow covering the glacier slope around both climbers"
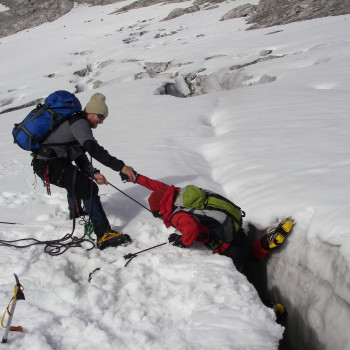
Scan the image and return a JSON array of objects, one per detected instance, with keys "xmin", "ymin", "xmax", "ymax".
[{"xmin": 0, "ymin": 0, "xmax": 350, "ymax": 350}]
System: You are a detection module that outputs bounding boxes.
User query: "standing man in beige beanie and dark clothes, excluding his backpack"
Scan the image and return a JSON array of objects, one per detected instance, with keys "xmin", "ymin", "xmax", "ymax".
[{"xmin": 32, "ymin": 93, "xmax": 136, "ymax": 250}]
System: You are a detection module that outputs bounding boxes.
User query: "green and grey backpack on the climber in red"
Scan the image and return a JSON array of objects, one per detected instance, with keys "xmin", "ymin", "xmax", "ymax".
[{"xmin": 172, "ymin": 185, "xmax": 245, "ymax": 242}]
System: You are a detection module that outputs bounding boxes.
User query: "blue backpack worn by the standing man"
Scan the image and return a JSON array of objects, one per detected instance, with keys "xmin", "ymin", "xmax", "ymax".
[{"xmin": 12, "ymin": 90, "xmax": 82, "ymax": 151}]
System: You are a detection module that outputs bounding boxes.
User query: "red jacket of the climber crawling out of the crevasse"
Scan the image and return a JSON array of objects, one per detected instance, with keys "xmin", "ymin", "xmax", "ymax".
[{"xmin": 136, "ymin": 175, "xmax": 210, "ymax": 246}]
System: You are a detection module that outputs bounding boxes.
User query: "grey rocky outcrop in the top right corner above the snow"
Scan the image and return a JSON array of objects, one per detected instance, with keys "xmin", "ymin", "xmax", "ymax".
[{"xmin": 248, "ymin": 0, "xmax": 350, "ymax": 29}]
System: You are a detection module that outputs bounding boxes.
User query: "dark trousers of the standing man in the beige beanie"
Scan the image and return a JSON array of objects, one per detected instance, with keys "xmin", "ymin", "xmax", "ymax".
[{"xmin": 33, "ymin": 158, "xmax": 111, "ymax": 237}]
